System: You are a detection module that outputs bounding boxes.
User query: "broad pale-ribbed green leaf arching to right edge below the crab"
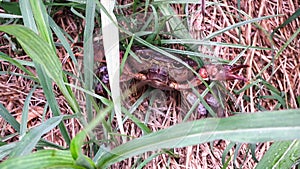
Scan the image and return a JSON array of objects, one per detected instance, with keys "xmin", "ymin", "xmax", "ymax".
[{"xmin": 97, "ymin": 109, "xmax": 300, "ymax": 167}]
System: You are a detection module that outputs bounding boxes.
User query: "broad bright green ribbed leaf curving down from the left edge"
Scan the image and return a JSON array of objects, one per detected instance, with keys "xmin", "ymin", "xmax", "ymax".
[{"xmin": 0, "ymin": 25, "xmax": 80, "ymax": 113}]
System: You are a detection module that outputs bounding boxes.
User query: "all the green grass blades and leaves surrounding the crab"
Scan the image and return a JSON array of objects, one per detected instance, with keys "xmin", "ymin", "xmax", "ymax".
[{"xmin": 0, "ymin": 0, "xmax": 300, "ymax": 168}]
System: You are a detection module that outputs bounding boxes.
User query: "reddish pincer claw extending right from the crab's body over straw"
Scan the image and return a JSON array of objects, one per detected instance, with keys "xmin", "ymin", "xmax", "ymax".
[{"xmin": 204, "ymin": 64, "xmax": 248, "ymax": 82}]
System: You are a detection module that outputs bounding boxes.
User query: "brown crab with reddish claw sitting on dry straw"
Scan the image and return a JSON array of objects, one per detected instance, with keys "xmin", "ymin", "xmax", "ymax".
[{"xmin": 95, "ymin": 49, "xmax": 248, "ymax": 114}]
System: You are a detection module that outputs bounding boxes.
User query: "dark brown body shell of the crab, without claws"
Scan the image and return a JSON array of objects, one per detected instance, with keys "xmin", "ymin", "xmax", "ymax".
[{"xmin": 121, "ymin": 49, "xmax": 207, "ymax": 90}]
